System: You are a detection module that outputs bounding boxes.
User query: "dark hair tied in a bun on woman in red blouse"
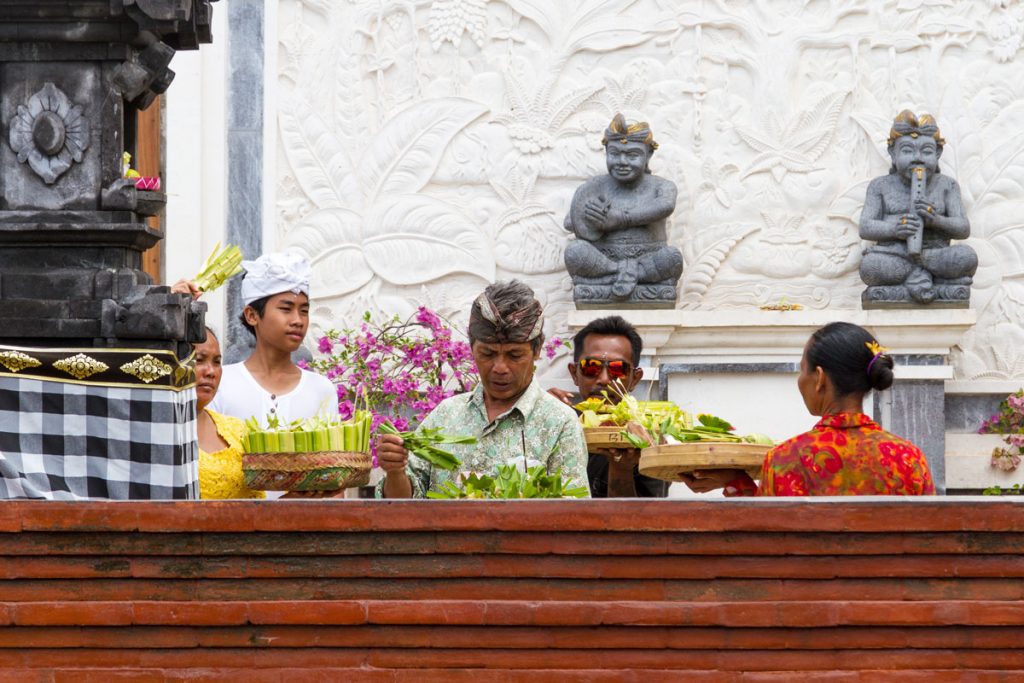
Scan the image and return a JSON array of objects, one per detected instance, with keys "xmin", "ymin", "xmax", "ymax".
[{"xmin": 807, "ymin": 323, "xmax": 893, "ymax": 396}]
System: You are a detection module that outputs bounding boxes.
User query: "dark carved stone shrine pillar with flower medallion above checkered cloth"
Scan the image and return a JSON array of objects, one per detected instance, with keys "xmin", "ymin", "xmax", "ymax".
[{"xmin": 0, "ymin": 0, "xmax": 212, "ymax": 355}]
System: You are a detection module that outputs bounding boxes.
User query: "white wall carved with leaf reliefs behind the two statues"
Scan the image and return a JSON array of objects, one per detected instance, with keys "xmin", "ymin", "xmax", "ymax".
[{"xmin": 271, "ymin": 0, "xmax": 1024, "ymax": 379}]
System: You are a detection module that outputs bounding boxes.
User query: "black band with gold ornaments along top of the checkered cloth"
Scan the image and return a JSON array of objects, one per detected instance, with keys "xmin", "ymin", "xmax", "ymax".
[{"xmin": 0, "ymin": 346, "xmax": 196, "ymax": 391}]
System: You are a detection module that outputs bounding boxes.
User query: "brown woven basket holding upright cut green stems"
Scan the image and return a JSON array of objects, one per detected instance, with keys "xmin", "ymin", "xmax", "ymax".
[{"xmin": 242, "ymin": 451, "xmax": 373, "ymax": 490}]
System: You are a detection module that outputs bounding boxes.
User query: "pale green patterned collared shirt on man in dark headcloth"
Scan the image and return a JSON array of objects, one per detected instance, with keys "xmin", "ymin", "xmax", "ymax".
[{"xmin": 377, "ymin": 380, "xmax": 588, "ymax": 498}]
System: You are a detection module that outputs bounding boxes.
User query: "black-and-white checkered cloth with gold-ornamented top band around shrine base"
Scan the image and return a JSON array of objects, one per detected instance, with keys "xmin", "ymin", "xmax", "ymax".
[{"xmin": 0, "ymin": 346, "xmax": 199, "ymax": 500}]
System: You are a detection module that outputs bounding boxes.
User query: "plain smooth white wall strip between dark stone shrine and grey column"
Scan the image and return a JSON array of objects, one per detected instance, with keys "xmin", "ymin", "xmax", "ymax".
[{"xmin": 164, "ymin": 2, "xmax": 229, "ymax": 333}]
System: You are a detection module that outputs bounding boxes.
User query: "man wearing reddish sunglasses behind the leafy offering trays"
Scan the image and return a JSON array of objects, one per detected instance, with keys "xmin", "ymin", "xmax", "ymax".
[{"xmin": 551, "ymin": 315, "xmax": 669, "ymax": 498}]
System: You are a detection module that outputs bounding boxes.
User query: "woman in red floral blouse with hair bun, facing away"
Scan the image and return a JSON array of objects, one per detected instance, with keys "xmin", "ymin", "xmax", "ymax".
[{"xmin": 683, "ymin": 323, "xmax": 935, "ymax": 496}]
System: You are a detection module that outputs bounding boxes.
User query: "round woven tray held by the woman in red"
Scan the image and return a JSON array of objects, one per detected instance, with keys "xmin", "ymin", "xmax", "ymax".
[{"xmin": 640, "ymin": 441, "xmax": 771, "ymax": 481}]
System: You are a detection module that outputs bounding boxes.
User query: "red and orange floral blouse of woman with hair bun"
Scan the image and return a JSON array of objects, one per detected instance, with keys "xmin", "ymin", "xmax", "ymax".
[{"xmin": 729, "ymin": 413, "xmax": 935, "ymax": 496}]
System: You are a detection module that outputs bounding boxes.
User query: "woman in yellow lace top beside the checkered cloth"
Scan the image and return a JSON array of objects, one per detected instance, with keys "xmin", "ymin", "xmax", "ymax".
[{"xmin": 196, "ymin": 328, "xmax": 266, "ymax": 499}]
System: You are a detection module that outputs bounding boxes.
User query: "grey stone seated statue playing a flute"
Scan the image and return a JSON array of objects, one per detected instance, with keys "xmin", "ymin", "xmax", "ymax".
[{"xmin": 860, "ymin": 111, "xmax": 978, "ymax": 308}]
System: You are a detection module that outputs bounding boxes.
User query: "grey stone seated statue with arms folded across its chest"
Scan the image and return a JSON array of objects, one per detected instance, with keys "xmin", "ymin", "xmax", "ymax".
[{"xmin": 565, "ymin": 114, "xmax": 683, "ymax": 308}]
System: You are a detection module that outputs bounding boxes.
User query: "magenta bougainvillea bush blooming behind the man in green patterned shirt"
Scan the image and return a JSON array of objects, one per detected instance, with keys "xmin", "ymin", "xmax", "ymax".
[{"xmin": 308, "ymin": 306, "xmax": 479, "ymax": 440}]
